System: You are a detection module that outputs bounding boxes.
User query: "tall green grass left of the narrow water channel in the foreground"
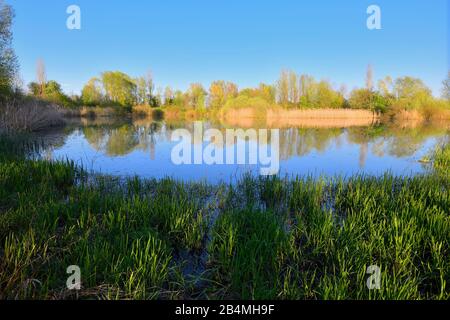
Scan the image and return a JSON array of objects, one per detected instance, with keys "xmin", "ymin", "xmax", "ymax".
[{"xmin": 0, "ymin": 136, "xmax": 206, "ymax": 299}]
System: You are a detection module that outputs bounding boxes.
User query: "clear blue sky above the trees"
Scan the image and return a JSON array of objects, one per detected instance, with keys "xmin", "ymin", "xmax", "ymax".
[{"xmin": 6, "ymin": 0, "xmax": 449, "ymax": 94}]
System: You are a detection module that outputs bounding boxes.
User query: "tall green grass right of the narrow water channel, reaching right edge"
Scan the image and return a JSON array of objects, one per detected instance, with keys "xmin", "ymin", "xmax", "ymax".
[{"xmin": 210, "ymin": 175, "xmax": 450, "ymax": 299}]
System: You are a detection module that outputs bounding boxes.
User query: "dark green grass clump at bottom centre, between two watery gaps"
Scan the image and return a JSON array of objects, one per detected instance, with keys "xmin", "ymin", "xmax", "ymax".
[{"xmin": 210, "ymin": 209, "xmax": 287, "ymax": 299}]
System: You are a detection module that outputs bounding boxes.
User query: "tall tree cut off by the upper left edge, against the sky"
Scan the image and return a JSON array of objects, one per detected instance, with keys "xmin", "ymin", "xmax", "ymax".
[{"xmin": 0, "ymin": 0, "xmax": 18, "ymax": 99}]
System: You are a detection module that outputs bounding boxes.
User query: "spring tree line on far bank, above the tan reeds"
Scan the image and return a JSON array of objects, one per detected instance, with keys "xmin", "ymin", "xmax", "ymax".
[{"xmin": 28, "ymin": 61, "xmax": 450, "ymax": 112}]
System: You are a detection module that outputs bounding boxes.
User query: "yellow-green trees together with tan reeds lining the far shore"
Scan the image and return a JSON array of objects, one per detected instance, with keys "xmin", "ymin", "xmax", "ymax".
[{"xmin": 22, "ymin": 66, "xmax": 450, "ymax": 124}]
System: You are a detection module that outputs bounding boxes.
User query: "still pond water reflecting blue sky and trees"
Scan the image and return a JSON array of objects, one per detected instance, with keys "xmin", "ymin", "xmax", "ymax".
[{"xmin": 42, "ymin": 119, "xmax": 450, "ymax": 183}]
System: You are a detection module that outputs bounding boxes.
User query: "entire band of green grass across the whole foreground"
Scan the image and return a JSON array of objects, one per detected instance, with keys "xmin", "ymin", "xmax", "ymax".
[{"xmin": 0, "ymin": 137, "xmax": 450, "ymax": 299}]
